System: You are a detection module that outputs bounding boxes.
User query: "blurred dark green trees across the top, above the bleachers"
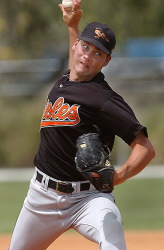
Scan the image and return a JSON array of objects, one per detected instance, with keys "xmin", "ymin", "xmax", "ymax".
[{"xmin": 0, "ymin": 0, "xmax": 164, "ymax": 59}]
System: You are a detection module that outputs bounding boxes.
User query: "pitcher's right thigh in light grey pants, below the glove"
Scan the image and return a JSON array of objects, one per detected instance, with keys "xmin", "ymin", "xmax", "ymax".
[{"xmin": 75, "ymin": 194, "xmax": 126, "ymax": 250}]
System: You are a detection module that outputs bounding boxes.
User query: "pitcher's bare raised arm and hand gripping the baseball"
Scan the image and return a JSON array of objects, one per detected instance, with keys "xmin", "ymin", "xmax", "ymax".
[{"xmin": 59, "ymin": 0, "xmax": 83, "ymax": 69}]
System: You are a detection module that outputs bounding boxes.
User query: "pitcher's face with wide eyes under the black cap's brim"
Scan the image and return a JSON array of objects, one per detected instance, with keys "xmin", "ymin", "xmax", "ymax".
[{"xmin": 71, "ymin": 40, "xmax": 111, "ymax": 81}]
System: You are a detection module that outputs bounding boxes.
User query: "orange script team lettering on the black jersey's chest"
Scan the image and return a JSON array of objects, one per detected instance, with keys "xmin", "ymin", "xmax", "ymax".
[{"xmin": 40, "ymin": 97, "xmax": 80, "ymax": 127}]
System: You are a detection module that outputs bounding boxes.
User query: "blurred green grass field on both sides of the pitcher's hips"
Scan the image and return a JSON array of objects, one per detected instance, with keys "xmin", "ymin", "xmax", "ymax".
[{"xmin": 0, "ymin": 178, "xmax": 164, "ymax": 233}]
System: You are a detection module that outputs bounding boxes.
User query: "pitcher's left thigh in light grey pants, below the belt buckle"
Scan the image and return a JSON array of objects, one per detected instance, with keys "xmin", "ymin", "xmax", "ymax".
[{"xmin": 9, "ymin": 180, "xmax": 64, "ymax": 250}]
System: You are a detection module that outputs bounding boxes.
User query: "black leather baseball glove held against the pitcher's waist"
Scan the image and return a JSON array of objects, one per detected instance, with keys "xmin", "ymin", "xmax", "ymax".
[{"xmin": 75, "ymin": 133, "xmax": 114, "ymax": 193}]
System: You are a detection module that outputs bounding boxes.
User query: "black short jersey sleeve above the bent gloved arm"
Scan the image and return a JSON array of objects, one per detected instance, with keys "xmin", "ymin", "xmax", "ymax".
[{"xmin": 101, "ymin": 94, "xmax": 148, "ymax": 145}]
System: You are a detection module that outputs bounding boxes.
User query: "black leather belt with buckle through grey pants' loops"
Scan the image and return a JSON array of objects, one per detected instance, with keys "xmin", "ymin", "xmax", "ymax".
[{"xmin": 36, "ymin": 171, "xmax": 90, "ymax": 194}]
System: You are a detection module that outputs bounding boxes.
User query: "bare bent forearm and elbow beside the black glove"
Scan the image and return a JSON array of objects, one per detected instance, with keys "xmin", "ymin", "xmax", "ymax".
[{"xmin": 114, "ymin": 133, "xmax": 155, "ymax": 185}]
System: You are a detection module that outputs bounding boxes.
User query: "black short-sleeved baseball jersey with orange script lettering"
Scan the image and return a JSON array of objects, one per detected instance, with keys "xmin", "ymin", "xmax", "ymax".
[{"xmin": 34, "ymin": 71, "xmax": 147, "ymax": 181}]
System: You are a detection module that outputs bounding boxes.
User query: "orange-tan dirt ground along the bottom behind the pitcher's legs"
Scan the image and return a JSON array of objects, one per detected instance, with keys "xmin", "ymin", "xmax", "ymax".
[{"xmin": 0, "ymin": 231, "xmax": 164, "ymax": 250}]
